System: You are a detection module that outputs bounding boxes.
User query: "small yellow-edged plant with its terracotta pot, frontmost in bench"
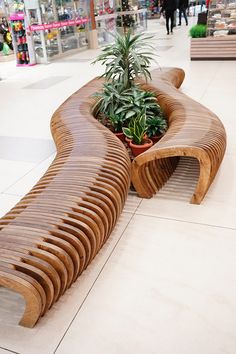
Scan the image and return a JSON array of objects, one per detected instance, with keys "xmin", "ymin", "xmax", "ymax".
[{"xmin": 123, "ymin": 109, "xmax": 153, "ymax": 156}]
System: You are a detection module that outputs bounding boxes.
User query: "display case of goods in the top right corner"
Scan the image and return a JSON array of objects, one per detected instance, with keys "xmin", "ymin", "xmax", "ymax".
[{"xmin": 207, "ymin": 0, "xmax": 236, "ymax": 37}]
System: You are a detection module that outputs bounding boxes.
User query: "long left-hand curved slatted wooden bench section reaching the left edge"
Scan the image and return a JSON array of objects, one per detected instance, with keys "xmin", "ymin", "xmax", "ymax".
[{"xmin": 0, "ymin": 79, "xmax": 130, "ymax": 327}]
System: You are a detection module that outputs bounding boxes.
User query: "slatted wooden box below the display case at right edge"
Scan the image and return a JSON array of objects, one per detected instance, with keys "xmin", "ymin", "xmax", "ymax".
[{"xmin": 190, "ymin": 35, "xmax": 236, "ymax": 60}]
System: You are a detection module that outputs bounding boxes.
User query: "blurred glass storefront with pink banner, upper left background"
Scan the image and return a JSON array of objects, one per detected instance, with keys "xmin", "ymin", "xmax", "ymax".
[{"xmin": 0, "ymin": 0, "xmax": 147, "ymax": 65}]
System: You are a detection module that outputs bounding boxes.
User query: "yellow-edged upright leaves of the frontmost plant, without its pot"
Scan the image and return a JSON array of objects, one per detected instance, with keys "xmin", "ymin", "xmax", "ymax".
[{"xmin": 123, "ymin": 109, "xmax": 147, "ymax": 145}]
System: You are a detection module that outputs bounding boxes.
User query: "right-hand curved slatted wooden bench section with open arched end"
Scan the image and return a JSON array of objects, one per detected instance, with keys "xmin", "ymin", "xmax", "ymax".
[{"xmin": 131, "ymin": 68, "xmax": 226, "ymax": 204}]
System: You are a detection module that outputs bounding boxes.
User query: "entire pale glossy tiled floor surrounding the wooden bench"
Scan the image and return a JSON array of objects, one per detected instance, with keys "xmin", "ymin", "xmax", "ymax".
[{"xmin": 0, "ymin": 19, "xmax": 236, "ymax": 354}]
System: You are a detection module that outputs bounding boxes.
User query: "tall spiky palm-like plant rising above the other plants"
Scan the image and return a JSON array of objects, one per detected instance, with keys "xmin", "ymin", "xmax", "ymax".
[{"xmin": 93, "ymin": 30, "xmax": 155, "ymax": 89}]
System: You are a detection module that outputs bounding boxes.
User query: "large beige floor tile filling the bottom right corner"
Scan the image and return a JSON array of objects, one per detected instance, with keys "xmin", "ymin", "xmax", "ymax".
[{"xmin": 56, "ymin": 215, "xmax": 236, "ymax": 354}]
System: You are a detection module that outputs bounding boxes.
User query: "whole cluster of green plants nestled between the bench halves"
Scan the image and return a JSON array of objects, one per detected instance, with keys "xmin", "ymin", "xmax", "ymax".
[{"xmin": 93, "ymin": 31, "xmax": 168, "ymax": 151}]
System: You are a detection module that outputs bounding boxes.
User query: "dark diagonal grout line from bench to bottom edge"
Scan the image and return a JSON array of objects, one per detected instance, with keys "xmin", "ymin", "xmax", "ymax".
[{"xmin": 53, "ymin": 213, "xmax": 135, "ymax": 354}]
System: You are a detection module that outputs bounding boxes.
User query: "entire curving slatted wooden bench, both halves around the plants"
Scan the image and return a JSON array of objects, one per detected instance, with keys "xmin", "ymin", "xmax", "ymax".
[{"xmin": 0, "ymin": 69, "xmax": 226, "ymax": 327}]
